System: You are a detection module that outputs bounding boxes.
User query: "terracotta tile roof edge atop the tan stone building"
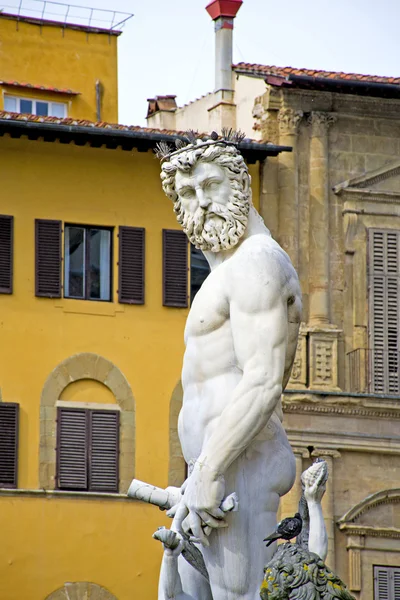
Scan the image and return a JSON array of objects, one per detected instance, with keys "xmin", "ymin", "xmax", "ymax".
[{"xmin": 233, "ymin": 62, "xmax": 400, "ymax": 85}]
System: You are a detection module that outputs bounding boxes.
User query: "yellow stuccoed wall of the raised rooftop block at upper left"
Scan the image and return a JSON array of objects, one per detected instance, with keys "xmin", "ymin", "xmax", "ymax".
[{"xmin": 0, "ymin": 16, "xmax": 118, "ymax": 123}]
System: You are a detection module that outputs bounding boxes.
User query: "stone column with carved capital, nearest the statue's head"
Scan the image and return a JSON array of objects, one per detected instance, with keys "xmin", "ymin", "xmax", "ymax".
[{"xmin": 278, "ymin": 108, "xmax": 303, "ymax": 269}]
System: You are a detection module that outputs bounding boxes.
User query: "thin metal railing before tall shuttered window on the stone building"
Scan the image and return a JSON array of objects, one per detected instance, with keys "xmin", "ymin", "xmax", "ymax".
[{"xmin": 347, "ymin": 348, "xmax": 400, "ymax": 396}]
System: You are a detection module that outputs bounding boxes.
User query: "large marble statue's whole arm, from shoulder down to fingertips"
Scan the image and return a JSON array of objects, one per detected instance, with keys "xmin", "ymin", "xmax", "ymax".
[{"xmin": 175, "ymin": 253, "xmax": 288, "ymax": 545}]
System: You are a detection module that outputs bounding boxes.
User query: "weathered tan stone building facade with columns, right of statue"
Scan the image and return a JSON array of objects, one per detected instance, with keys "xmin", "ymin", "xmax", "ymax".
[{"xmin": 252, "ymin": 65, "xmax": 400, "ymax": 600}]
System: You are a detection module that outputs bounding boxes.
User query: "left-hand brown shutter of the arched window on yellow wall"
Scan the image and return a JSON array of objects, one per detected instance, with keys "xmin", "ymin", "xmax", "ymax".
[{"xmin": 57, "ymin": 408, "xmax": 89, "ymax": 490}]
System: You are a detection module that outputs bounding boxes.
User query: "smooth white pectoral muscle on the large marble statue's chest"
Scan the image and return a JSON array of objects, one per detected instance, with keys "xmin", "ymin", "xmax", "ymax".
[{"xmin": 185, "ymin": 265, "xmax": 229, "ymax": 343}]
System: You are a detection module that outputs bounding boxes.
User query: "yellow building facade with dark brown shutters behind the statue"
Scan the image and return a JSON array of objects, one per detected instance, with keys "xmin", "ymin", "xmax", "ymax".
[{"xmin": 0, "ymin": 10, "xmax": 288, "ymax": 600}]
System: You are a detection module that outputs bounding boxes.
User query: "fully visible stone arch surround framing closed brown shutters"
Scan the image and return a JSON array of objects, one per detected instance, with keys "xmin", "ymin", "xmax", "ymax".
[{"xmin": 39, "ymin": 352, "xmax": 135, "ymax": 493}]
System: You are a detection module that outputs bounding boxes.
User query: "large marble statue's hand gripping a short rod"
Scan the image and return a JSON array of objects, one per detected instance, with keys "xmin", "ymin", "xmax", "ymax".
[{"xmin": 174, "ymin": 462, "xmax": 227, "ymax": 546}]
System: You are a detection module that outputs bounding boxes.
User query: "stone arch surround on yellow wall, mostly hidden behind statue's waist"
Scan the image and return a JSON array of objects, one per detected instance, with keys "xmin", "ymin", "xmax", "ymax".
[{"xmin": 168, "ymin": 380, "xmax": 186, "ymax": 487}]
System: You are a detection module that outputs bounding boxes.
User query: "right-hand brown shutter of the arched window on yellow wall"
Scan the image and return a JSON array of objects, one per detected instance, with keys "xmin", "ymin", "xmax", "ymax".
[{"xmin": 89, "ymin": 410, "xmax": 119, "ymax": 492}]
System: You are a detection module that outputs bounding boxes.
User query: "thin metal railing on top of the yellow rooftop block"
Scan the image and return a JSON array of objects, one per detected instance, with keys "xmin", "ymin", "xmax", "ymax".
[{"xmin": 0, "ymin": 0, "xmax": 133, "ymax": 31}]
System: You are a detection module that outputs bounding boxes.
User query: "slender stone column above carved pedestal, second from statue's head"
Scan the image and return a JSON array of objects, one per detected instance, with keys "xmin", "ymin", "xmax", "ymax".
[{"xmin": 308, "ymin": 112, "xmax": 335, "ymax": 325}]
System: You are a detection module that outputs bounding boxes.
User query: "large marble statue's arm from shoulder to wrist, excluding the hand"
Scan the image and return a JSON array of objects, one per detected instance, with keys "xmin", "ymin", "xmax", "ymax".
[{"xmin": 198, "ymin": 258, "xmax": 288, "ymax": 475}]
